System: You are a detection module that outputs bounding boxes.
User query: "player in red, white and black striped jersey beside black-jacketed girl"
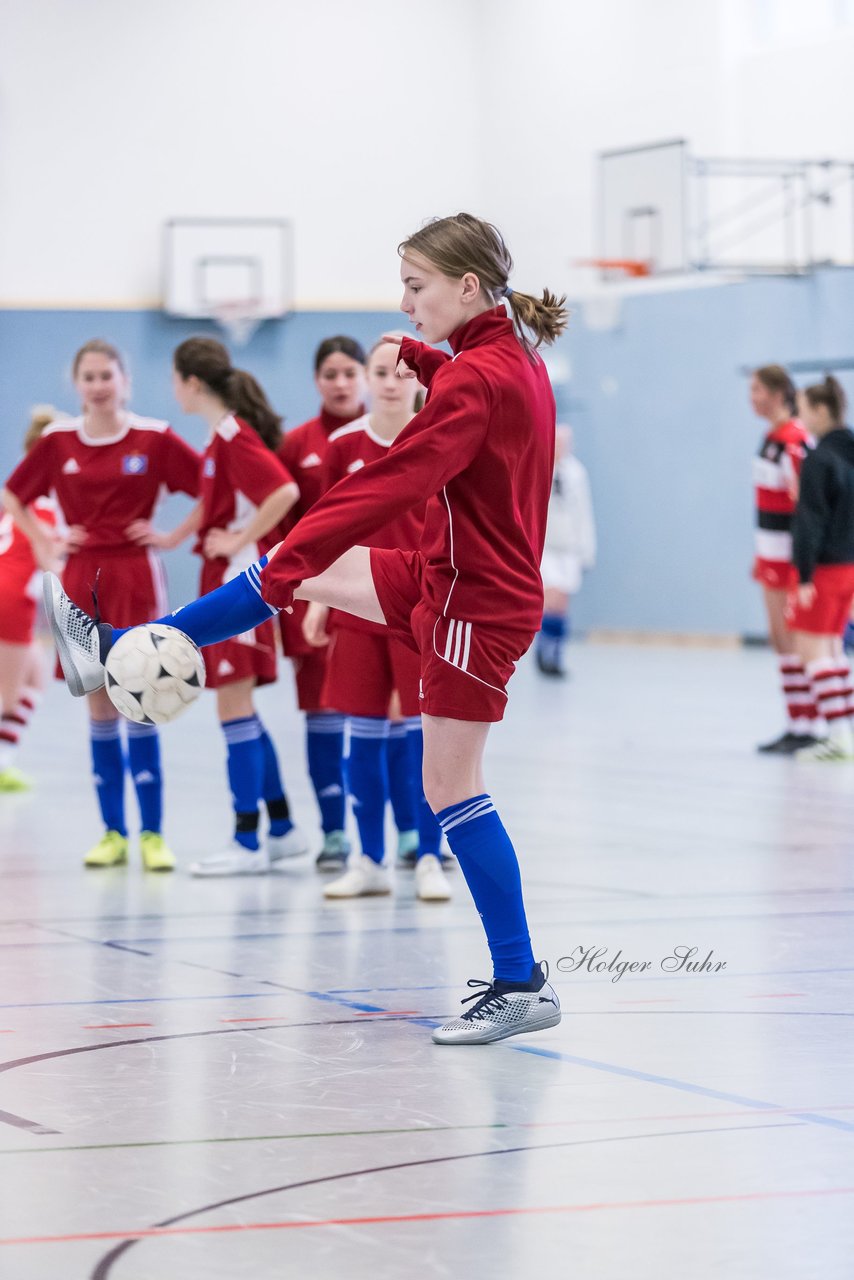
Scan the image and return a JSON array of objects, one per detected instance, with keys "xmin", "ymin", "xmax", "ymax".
[{"xmin": 750, "ymin": 365, "xmax": 818, "ymax": 755}]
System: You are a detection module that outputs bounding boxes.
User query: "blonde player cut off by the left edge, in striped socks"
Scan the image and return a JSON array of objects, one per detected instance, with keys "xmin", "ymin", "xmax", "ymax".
[{"xmin": 0, "ymin": 404, "xmax": 63, "ymax": 791}]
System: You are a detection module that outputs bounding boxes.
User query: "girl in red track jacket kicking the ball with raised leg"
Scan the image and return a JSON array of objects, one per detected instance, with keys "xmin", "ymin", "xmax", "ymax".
[{"xmin": 49, "ymin": 214, "xmax": 566, "ymax": 1044}]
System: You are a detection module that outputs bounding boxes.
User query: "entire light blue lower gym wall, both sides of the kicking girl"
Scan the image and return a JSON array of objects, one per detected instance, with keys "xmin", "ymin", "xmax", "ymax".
[{"xmin": 0, "ymin": 280, "xmax": 854, "ymax": 634}]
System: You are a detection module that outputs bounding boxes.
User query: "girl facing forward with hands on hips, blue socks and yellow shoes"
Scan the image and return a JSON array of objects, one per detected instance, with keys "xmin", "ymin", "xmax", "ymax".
[{"xmin": 4, "ymin": 338, "xmax": 198, "ymax": 870}]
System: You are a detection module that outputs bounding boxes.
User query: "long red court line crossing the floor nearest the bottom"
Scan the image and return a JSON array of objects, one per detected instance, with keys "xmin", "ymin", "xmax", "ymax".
[{"xmin": 0, "ymin": 1187, "xmax": 854, "ymax": 1245}]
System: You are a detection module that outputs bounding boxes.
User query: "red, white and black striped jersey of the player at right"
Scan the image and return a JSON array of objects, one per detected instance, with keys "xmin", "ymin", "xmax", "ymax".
[{"xmin": 753, "ymin": 417, "xmax": 812, "ymax": 564}]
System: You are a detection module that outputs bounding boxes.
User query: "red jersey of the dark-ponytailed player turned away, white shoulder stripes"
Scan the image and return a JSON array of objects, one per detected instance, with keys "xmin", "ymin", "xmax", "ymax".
[{"xmin": 195, "ymin": 415, "xmax": 292, "ymax": 567}]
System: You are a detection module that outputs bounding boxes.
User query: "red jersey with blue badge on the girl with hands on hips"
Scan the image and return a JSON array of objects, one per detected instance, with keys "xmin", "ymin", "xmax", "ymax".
[{"xmin": 6, "ymin": 413, "xmax": 198, "ymax": 554}]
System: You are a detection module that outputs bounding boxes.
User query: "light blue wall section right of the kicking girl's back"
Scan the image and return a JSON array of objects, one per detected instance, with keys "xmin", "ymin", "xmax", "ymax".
[{"xmin": 562, "ymin": 271, "xmax": 854, "ymax": 635}]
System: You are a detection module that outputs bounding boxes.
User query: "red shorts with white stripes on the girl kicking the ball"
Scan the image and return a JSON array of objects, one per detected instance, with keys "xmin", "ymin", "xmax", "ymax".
[{"xmin": 370, "ymin": 548, "xmax": 534, "ymax": 721}]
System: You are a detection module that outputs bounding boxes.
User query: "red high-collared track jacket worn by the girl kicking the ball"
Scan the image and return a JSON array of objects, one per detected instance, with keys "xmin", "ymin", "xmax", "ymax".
[{"xmin": 261, "ymin": 307, "xmax": 554, "ymax": 632}]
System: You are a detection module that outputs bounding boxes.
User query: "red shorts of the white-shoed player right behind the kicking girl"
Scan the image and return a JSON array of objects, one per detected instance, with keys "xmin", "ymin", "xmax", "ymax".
[{"xmin": 323, "ymin": 627, "xmax": 421, "ymax": 718}]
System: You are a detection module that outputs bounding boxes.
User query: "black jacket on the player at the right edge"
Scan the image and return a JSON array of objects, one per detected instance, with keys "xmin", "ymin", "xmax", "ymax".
[{"xmin": 791, "ymin": 426, "xmax": 854, "ymax": 582}]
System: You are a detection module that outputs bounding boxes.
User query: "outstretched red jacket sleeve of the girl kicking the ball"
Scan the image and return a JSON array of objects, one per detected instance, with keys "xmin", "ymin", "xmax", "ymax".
[{"xmin": 261, "ymin": 365, "xmax": 490, "ymax": 609}]
